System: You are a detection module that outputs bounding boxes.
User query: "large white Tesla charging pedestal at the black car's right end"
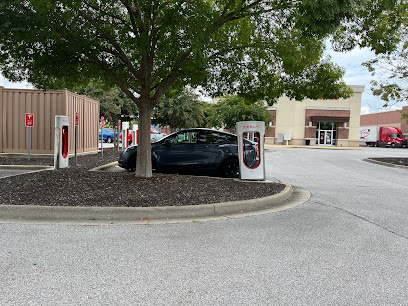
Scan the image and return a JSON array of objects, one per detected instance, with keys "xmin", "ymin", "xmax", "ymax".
[{"xmin": 236, "ymin": 121, "xmax": 265, "ymax": 181}]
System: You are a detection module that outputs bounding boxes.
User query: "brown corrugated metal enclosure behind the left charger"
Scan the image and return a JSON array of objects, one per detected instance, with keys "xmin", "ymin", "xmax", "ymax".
[{"xmin": 0, "ymin": 86, "xmax": 100, "ymax": 154}]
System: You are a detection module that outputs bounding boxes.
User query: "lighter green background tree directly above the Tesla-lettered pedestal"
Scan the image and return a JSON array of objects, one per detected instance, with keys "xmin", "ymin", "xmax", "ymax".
[{"xmin": 208, "ymin": 96, "xmax": 272, "ymax": 130}]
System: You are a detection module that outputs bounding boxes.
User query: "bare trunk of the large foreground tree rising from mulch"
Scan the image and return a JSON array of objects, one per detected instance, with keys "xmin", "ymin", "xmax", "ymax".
[{"xmin": 136, "ymin": 103, "xmax": 153, "ymax": 178}]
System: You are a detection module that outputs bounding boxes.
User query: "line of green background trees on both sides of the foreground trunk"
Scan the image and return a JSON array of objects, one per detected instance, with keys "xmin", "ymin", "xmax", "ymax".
[{"xmin": 77, "ymin": 84, "xmax": 272, "ymax": 131}]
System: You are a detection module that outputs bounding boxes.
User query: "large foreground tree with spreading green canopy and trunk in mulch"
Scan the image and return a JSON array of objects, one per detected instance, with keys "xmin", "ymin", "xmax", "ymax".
[{"xmin": 0, "ymin": 0, "xmax": 404, "ymax": 177}]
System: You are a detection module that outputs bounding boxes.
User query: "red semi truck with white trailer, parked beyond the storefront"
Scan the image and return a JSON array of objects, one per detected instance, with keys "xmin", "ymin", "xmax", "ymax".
[{"xmin": 360, "ymin": 126, "xmax": 407, "ymax": 148}]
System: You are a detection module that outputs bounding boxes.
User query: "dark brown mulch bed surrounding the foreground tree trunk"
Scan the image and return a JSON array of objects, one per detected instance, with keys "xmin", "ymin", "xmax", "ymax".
[{"xmin": 0, "ymin": 149, "xmax": 285, "ymax": 207}]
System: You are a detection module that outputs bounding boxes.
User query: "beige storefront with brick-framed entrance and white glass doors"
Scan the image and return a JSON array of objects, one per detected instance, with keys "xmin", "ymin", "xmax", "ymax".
[{"xmin": 265, "ymin": 85, "xmax": 364, "ymax": 147}]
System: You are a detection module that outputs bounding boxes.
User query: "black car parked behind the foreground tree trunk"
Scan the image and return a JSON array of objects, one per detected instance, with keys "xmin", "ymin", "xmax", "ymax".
[{"xmin": 119, "ymin": 128, "xmax": 258, "ymax": 177}]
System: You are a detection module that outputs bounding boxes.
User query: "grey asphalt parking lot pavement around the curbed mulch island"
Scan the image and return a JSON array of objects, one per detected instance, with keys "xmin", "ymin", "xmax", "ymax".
[{"xmin": 0, "ymin": 147, "xmax": 408, "ymax": 305}]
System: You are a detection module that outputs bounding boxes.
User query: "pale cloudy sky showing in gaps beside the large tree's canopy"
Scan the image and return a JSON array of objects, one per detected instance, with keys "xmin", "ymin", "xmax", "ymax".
[{"xmin": 0, "ymin": 47, "xmax": 403, "ymax": 114}]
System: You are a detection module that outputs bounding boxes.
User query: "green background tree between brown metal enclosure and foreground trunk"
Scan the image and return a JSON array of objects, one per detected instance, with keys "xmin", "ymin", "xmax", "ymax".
[{"xmin": 76, "ymin": 83, "xmax": 138, "ymax": 125}]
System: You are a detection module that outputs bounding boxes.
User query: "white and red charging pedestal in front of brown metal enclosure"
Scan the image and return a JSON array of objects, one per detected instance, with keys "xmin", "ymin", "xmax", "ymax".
[{"xmin": 54, "ymin": 116, "xmax": 69, "ymax": 169}]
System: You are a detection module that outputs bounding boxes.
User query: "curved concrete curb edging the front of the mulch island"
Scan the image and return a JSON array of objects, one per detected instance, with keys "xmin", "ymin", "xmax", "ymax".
[{"xmin": 0, "ymin": 185, "xmax": 310, "ymax": 225}]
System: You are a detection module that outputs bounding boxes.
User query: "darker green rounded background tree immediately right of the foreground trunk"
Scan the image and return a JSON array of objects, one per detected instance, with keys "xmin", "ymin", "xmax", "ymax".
[{"xmin": 152, "ymin": 89, "xmax": 206, "ymax": 129}]
